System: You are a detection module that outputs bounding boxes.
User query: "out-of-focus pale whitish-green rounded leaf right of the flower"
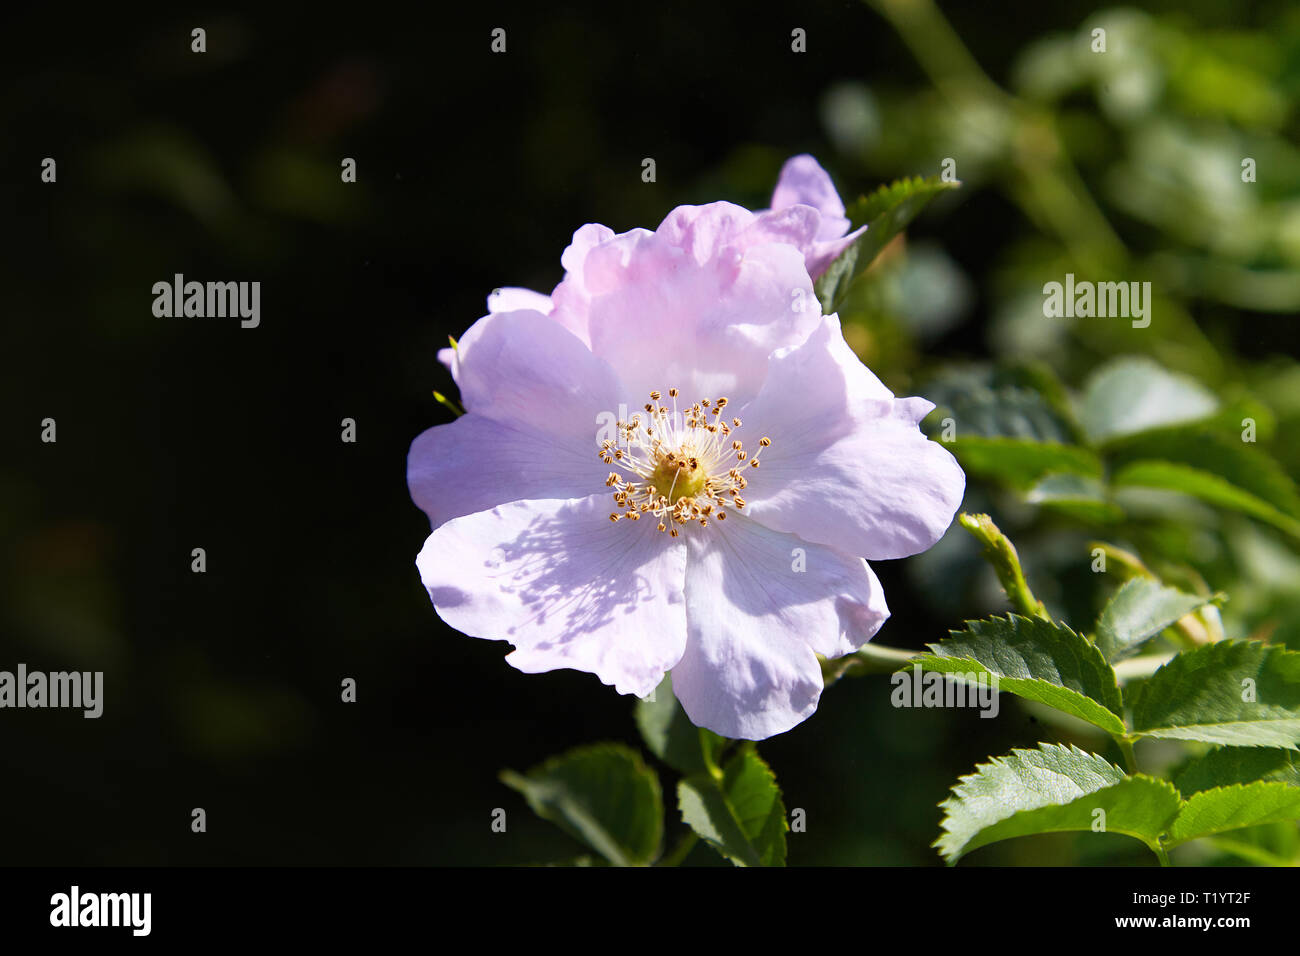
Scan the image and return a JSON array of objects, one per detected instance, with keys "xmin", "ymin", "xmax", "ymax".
[{"xmin": 1079, "ymin": 358, "xmax": 1218, "ymax": 444}]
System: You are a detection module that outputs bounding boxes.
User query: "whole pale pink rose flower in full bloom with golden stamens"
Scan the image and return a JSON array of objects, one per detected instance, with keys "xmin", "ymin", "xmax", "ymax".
[{"xmin": 407, "ymin": 157, "xmax": 965, "ymax": 740}]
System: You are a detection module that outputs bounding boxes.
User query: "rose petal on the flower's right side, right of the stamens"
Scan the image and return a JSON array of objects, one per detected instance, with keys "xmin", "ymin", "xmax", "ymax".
[{"xmin": 741, "ymin": 316, "xmax": 966, "ymax": 561}]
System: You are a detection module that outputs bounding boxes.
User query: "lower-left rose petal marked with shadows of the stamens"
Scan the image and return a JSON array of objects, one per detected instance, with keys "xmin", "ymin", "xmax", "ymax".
[{"xmin": 416, "ymin": 494, "xmax": 686, "ymax": 697}]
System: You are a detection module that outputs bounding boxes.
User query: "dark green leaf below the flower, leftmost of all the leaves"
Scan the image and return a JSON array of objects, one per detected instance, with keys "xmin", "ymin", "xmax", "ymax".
[{"xmin": 501, "ymin": 744, "xmax": 663, "ymax": 866}]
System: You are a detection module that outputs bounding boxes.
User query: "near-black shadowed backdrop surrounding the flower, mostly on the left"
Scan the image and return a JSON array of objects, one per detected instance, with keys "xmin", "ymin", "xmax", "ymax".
[{"xmin": 0, "ymin": 3, "xmax": 1290, "ymax": 865}]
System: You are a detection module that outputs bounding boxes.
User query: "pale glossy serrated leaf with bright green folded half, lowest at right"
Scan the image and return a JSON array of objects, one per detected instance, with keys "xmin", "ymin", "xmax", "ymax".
[{"xmin": 933, "ymin": 744, "xmax": 1179, "ymax": 865}]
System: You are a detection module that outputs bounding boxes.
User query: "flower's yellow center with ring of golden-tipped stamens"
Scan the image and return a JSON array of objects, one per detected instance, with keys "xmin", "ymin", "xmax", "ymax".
[{"xmin": 598, "ymin": 389, "xmax": 772, "ymax": 537}]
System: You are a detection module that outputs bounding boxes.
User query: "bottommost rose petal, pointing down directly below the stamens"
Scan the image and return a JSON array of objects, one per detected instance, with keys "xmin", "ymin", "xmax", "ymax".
[{"xmin": 672, "ymin": 514, "xmax": 889, "ymax": 740}]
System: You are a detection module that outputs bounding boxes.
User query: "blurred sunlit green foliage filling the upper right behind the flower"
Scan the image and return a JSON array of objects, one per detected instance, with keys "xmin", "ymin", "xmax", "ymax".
[{"xmin": 823, "ymin": 0, "xmax": 1300, "ymax": 862}]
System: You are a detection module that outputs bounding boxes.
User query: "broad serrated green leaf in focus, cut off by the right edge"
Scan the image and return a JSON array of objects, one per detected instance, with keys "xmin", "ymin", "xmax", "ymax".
[{"xmin": 1132, "ymin": 641, "xmax": 1300, "ymax": 750}]
